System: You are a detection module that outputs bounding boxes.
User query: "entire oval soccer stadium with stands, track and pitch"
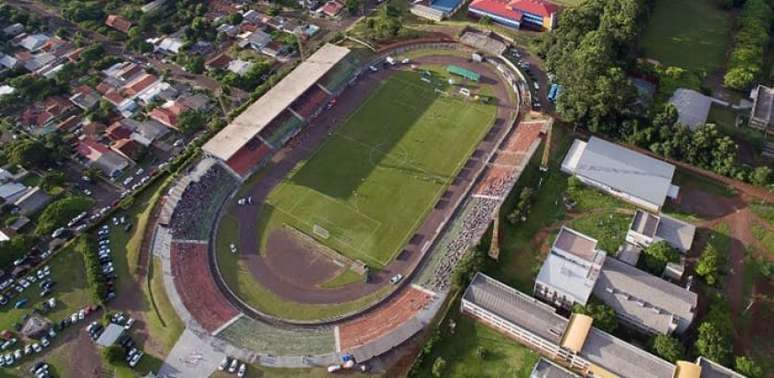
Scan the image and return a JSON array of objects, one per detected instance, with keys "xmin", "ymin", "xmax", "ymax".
[{"xmin": 153, "ymin": 39, "xmax": 544, "ymax": 376}]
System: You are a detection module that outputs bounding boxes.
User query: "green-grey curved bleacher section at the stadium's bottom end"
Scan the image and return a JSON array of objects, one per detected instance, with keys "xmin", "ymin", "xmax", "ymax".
[{"xmin": 217, "ymin": 316, "xmax": 335, "ymax": 356}]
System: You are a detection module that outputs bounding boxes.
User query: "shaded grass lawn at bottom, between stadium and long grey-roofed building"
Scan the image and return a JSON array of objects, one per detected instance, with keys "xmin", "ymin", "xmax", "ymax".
[{"xmin": 417, "ymin": 305, "xmax": 539, "ymax": 378}]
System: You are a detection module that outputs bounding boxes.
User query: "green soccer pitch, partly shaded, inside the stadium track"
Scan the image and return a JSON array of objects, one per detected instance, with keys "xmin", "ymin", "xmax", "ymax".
[{"xmin": 260, "ymin": 72, "xmax": 496, "ymax": 268}]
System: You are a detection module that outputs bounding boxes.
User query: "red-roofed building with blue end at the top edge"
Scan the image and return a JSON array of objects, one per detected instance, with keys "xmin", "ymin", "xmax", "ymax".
[{"xmin": 468, "ymin": 0, "xmax": 559, "ymax": 30}]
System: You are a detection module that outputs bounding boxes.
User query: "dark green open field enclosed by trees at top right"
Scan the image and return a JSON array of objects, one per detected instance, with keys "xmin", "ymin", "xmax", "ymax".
[{"xmin": 640, "ymin": 0, "xmax": 732, "ymax": 73}]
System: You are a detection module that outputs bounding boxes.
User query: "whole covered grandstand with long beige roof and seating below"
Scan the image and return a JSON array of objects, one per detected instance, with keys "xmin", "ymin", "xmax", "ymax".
[{"xmin": 202, "ymin": 44, "xmax": 357, "ymax": 178}]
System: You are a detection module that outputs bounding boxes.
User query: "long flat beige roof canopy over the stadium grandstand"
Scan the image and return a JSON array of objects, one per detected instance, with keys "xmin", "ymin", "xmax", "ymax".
[{"xmin": 202, "ymin": 44, "xmax": 349, "ymax": 161}]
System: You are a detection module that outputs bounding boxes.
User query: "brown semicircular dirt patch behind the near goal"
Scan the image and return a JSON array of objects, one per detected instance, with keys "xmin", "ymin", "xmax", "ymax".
[{"xmin": 264, "ymin": 228, "xmax": 345, "ymax": 287}]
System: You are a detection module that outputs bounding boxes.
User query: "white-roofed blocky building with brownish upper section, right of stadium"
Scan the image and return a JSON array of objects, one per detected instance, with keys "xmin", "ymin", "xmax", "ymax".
[{"xmin": 534, "ymin": 227, "xmax": 605, "ymax": 310}]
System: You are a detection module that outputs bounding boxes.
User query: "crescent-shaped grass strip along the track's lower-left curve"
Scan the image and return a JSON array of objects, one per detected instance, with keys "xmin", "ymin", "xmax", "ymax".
[{"xmin": 216, "ymin": 215, "xmax": 392, "ymax": 320}]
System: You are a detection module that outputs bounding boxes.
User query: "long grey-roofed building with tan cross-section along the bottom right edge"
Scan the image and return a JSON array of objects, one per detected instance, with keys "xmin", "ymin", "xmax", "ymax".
[{"xmin": 460, "ymin": 274, "xmax": 742, "ymax": 378}]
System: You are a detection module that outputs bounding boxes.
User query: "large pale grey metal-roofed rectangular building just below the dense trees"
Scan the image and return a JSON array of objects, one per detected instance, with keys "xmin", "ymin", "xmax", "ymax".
[{"xmin": 562, "ymin": 137, "xmax": 679, "ymax": 212}]
